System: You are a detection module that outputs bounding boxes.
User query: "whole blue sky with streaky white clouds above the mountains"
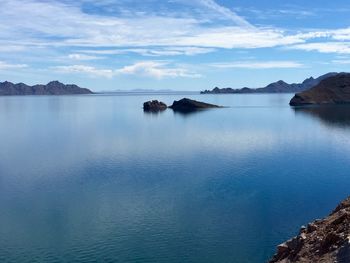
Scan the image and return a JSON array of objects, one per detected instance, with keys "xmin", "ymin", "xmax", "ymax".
[{"xmin": 0, "ymin": 0, "xmax": 350, "ymax": 91}]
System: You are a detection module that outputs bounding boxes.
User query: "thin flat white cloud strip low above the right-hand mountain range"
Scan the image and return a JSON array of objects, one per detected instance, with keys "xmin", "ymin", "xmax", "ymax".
[{"xmin": 211, "ymin": 61, "xmax": 303, "ymax": 69}]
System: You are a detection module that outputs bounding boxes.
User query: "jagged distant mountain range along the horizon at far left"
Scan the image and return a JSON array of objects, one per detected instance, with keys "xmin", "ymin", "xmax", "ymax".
[{"xmin": 0, "ymin": 81, "xmax": 93, "ymax": 96}]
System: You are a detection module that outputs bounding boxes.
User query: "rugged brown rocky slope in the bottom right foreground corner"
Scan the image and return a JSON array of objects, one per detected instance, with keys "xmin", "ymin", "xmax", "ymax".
[{"xmin": 270, "ymin": 197, "xmax": 350, "ymax": 263}]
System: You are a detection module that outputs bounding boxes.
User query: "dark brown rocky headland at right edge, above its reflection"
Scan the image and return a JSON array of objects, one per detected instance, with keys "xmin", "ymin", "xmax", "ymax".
[{"xmin": 289, "ymin": 73, "xmax": 350, "ymax": 106}]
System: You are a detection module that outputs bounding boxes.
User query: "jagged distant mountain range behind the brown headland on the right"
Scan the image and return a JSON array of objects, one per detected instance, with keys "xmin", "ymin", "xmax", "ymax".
[{"xmin": 201, "ymin": 72, "xmax": 338, "ymax": 94}]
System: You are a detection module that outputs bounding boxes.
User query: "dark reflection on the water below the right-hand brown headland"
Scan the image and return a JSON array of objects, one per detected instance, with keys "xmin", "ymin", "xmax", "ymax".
[{"xmin": 294, "ymin": 105, "xmax": 350, "ymax": 126}]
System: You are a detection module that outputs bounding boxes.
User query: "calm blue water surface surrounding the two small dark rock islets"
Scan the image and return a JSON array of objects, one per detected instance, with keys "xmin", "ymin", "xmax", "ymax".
[{"xmin": 0, "ymin": 94, "xmax": 350, "ymax": 263}]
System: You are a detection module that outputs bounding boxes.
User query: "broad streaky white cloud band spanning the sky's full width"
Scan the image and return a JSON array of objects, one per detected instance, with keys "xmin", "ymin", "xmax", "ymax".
[{"xmin": 0, "ymin": 0, "xmax": 350, "ymax": 60}]
